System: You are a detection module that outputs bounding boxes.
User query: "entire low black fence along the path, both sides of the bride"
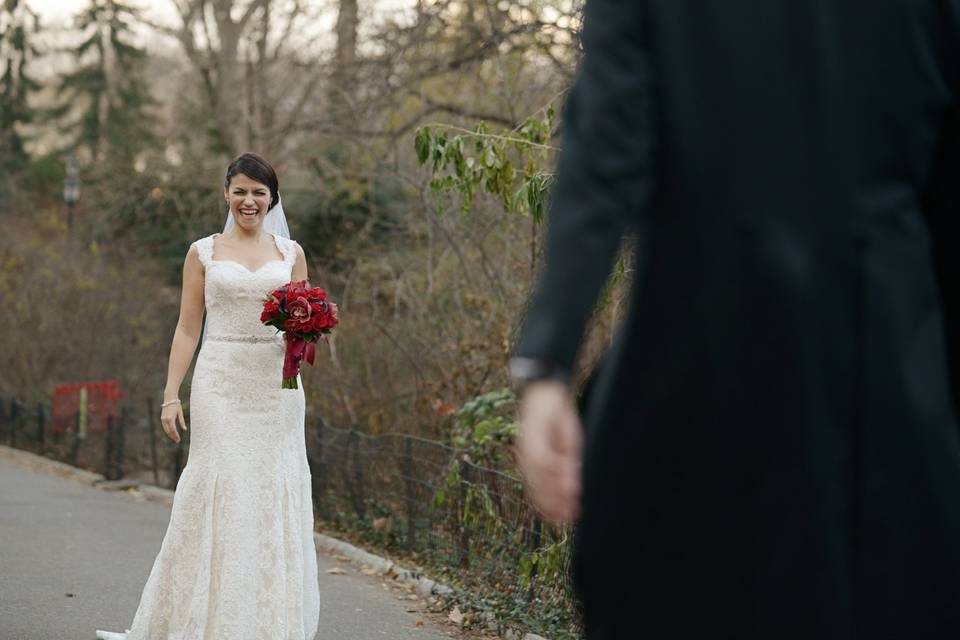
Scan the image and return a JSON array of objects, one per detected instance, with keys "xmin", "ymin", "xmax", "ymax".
[{"xmin": 0, "ymin": 398, "xmax": 579, "ymax": 638}]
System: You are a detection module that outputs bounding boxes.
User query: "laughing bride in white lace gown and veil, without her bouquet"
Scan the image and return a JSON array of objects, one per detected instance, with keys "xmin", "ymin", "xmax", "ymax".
[{"xmin": 96, "ymin": 153, "xmax": 320, "ymax": 640}]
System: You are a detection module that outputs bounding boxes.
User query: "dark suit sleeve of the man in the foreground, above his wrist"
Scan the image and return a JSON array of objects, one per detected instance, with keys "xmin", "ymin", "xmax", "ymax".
[{"xmin": 516, "ymin": 0, "xmax": 656, "ymax": 373}]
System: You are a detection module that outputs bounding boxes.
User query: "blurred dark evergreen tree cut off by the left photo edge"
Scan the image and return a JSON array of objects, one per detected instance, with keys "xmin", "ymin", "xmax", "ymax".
[{"xmin": 0, "ymin": 0, "xmax": 39, "ymax": 174}]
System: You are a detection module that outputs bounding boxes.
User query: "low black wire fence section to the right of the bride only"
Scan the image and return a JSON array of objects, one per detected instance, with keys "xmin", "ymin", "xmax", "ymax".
[{"xmin": 308, "ymin": 419, "xmax": 576, "ymax": 632}]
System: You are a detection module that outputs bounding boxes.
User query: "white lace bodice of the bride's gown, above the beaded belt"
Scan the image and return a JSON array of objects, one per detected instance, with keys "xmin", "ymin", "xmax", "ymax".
[{"xmin": 193, "ymin": 235, "xmax": 297, "ymax": 340}]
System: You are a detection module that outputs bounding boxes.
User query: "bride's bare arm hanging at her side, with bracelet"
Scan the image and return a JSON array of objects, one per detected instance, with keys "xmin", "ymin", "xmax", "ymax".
[{"xmin": 160, "ymin": 246, "xmax": 203, "ymax": 442}]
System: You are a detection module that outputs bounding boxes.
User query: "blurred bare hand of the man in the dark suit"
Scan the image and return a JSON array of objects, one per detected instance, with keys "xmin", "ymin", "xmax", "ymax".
[{"xmin": 517, "ymin": 380, "xmax": 583, "ymax": 524}]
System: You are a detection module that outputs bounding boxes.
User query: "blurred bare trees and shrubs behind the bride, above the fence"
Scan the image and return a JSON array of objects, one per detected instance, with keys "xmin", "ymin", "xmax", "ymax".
[{"xmin": 0, "ymin": 0, "xmax": 625, "ymax": 636}]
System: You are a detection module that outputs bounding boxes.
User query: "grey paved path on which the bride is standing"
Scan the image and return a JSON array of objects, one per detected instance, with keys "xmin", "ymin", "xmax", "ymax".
[{"xmin": 0, "ymin": 458, "xmax": 450, "ymax": 640}]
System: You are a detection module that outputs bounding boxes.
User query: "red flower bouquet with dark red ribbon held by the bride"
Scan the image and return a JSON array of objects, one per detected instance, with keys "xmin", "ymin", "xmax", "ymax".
[{"xmin": 260, "ymin": 280, "xmax": 340, "ymax": 389}]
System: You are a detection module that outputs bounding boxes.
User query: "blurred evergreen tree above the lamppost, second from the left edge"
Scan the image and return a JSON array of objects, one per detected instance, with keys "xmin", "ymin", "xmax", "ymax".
[{"xmin": 54, "ymin": 0, "xmax": 153, "ymax": 163}]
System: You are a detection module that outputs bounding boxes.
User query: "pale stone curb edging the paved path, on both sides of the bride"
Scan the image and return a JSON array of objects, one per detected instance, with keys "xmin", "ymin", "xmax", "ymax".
[{"xmin": 0, "ymin": 445, "xmax": 546, "ymax": 640}]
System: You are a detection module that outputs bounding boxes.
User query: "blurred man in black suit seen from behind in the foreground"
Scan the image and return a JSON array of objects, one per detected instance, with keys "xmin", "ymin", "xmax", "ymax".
[{"xmin": 511, "ymin": 0, "xmax": 960, "ymax": 640}]
